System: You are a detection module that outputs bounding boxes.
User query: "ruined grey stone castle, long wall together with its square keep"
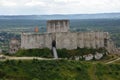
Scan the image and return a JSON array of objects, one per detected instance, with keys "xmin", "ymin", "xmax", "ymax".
[{"xmin": 21, "ymin": 20, "xmax": 113, "ymax": 49}]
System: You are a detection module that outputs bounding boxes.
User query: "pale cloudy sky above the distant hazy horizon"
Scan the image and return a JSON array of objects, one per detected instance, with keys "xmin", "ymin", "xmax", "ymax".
[{"xmin": 0, "ymin": 0, "xmax": 120, "ymax": 15}]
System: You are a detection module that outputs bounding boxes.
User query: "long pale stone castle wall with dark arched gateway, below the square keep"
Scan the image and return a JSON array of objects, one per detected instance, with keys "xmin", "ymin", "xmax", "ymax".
[{"xmin": 21, "ymin": 32, "xmax": 109, "ymax": 49}]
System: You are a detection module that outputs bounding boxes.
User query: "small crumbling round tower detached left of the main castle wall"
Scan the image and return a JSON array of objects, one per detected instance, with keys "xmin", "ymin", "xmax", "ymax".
[{"xmin": 9, "ymin": 39, "xmax": 20, "ymax": 54}]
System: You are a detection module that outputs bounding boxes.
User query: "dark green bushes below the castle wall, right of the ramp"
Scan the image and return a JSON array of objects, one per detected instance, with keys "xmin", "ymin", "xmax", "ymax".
[{"xmin": 57, "ymin": 47, "xmax": 107, "ymax": 59}]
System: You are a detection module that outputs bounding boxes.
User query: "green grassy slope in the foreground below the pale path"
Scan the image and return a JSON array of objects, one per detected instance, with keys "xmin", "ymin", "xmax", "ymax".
[{"xmin": 0, "ymin": 60, "xmax": 120, "ymax": 80}]
